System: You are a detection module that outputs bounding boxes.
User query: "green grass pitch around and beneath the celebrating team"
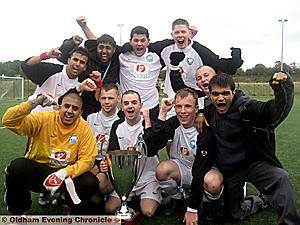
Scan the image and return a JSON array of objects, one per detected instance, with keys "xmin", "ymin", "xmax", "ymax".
[{"xmin": 0, "ymin": 96, "xmax": 300, "ymax": 225}]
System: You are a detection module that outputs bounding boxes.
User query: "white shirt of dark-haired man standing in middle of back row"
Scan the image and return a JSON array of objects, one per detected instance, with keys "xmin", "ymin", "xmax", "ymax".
[{"xmin": 119, "ymin": 51, "xmax": 161, "ymax": 109}]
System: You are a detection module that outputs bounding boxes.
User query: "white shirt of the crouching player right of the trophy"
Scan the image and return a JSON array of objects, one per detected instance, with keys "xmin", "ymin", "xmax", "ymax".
[{"xmin": 170, "ymin": 125, "xmax": 198, "ymax": 169}]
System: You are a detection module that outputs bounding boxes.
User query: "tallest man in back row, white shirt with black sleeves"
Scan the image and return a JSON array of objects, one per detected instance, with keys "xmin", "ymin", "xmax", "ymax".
[{"xmin": 150, "ymin": 18, "xmax": 243, "ymax": 117}]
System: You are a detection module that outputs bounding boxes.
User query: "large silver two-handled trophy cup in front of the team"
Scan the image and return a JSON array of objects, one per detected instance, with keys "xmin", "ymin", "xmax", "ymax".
[{"xmin": 109, "ymin": 134, "xmax": 147, "ymax": 220}]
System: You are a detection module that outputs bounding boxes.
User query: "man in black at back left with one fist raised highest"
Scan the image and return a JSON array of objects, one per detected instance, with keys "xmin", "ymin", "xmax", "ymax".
[{"xmin": 60, "ymin": 31, "xmax": 121, "ymax": 119}]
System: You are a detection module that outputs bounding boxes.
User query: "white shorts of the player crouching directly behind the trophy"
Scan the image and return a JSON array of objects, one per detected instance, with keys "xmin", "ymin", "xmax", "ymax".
[{"xmin": 110, "ymin": 181, "xmax": 161, "ymax": 204}]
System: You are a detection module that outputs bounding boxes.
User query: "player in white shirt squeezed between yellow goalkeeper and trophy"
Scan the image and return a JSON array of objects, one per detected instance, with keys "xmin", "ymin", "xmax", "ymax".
[{"xmin": 87, "ymin": 83, "xmax": 120, "ymax": 194}]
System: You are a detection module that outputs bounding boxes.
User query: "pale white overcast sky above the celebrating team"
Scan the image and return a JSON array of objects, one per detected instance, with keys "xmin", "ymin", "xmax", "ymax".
[{"xmin": 0, "ymin": 0, "xmax": 300, "ymax": 70}]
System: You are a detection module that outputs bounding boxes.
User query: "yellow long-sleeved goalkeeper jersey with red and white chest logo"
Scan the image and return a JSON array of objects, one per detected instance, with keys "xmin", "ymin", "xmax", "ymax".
[{"xmin": 2, "ymin": 102, "xmax": 97, "ymax": 178}]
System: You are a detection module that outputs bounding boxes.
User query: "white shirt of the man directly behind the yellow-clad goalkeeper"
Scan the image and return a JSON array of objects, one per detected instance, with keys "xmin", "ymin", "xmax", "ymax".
[{"xmin": 32, "ymin": 66, "xmax": 79, "ymax": 112}]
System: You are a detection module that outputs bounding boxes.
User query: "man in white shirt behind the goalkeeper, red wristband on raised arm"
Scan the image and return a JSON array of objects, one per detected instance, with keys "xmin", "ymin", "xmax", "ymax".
[{"xmin": 21, "ymin": 47, "xmax": 89, "ymax": 112}]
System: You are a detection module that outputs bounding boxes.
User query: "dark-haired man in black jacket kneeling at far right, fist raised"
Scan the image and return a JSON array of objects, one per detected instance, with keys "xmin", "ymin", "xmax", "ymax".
[{"xmin": 185, "ymin": 72, "xmax": 300, "ymax": 225}]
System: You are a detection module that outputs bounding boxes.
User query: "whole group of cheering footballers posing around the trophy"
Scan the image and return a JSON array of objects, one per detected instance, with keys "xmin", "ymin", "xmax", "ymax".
[{"xmin": 2, "ymin": 17, "xmax": 300, "ymax": 225}]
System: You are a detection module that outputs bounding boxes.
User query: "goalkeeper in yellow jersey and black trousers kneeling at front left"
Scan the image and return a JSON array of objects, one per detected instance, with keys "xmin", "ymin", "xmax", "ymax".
[{"xmin": 2, "ymin": 92, "xmax": 99, "ymax": 215}]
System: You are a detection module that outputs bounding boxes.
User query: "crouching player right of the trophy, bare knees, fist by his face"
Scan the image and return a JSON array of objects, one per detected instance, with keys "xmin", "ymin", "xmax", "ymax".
[{"xmin": 154, "ymin": 88, "xmax": 223, "ymax": 215}]
